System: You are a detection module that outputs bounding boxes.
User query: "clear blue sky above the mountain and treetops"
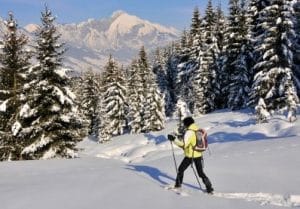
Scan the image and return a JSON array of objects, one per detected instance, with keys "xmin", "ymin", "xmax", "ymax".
[{"xmin": 0, "ymin": 0, "xmax": 228, "ymax": 29}]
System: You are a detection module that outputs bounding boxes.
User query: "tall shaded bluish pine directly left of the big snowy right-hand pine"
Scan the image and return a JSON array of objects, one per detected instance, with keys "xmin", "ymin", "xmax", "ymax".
[{"xmin": 228, "ymin": 0, "xmax": 254, "ymax": 110}]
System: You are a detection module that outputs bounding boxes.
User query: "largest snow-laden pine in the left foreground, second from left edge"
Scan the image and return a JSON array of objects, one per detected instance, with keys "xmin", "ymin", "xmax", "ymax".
[{"xmin": 18, "ymin": 6, "xmax": 82, "ymax": 159}]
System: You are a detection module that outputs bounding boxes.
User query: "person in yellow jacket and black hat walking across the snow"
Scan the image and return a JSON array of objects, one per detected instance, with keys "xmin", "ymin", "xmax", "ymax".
[{"xmin": 168, "ymin": 117, "xmax": 214, "ymax": 193}]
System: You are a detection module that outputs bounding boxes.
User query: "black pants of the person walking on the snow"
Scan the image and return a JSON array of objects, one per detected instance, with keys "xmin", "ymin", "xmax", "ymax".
[{"xmin": 175, "ymin": 157, "xmax": 212, "ymax": 191}]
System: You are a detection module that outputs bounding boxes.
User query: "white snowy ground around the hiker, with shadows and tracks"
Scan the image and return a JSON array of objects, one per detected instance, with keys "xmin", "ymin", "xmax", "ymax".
[{"xmin": 0, "ymin": 111, "xmax": 300, "ymax": 209}]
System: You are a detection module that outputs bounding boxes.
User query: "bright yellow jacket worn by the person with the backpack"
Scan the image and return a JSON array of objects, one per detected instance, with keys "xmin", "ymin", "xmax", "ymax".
[{"xmin": 174, "ymin": 123, "xmax": 202, "ymax": 158}]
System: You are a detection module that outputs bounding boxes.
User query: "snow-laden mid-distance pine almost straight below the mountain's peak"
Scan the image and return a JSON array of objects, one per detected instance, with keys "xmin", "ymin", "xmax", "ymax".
[{"xmin": 99, "ymin": 56, "xmax": 127, "ymax": 142}]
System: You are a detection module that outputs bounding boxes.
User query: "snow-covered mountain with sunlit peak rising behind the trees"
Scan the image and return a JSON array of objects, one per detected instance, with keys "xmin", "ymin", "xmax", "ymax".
[{"xmin": 24, "ymin": 11, "xmax": 179, "ymax": 71}]
